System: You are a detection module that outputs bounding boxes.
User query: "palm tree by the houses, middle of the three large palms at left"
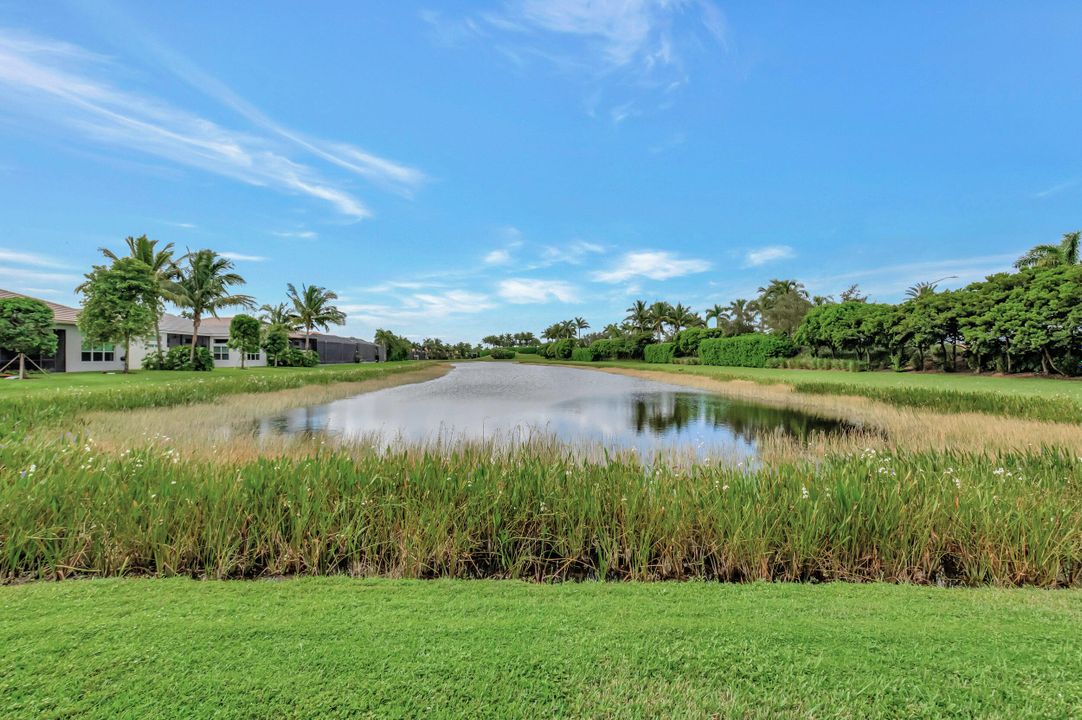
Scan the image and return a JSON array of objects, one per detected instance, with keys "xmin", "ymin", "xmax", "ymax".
[{"xmin": 164, "ymin": 250, "xmax": 255, "ymax": 363}]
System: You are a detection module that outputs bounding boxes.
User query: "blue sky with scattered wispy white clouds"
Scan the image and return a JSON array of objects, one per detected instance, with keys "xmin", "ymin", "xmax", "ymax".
[{"xmin": 0, "ymin": 0, "xmax": 1082, "ymax": 341}]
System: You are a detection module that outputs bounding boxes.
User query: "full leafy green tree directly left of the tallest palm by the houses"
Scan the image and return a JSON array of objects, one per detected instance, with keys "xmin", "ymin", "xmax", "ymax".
[{"xmin": 79, "ymin": 258, "xmax": 160, "ymax": 372}]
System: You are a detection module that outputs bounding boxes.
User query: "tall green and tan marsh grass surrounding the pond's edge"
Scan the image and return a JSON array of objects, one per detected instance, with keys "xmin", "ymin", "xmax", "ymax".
[{"xmin": 0, "ymin": 365, "xmax": 1082, "ymax": 588}]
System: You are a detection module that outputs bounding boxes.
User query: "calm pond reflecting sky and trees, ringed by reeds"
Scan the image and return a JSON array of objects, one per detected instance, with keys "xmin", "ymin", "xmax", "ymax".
[{"xmin": 256, "ymin": 362, "xmax": 850, "ymax": 457}]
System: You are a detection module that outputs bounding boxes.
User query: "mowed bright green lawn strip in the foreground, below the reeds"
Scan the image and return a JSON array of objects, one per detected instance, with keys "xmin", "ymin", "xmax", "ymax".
[{"xmin": 0, "ymin": 577, "xmax": 1082, "ymax": 718}]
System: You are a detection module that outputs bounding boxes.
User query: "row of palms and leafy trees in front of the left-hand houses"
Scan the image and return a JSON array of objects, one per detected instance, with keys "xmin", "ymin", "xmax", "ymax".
[{"xmin": 70, "ymin": 235, "xmax": 345, "ymax": 372}]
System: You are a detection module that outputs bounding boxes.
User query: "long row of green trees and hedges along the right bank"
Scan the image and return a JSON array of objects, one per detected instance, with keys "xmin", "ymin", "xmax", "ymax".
[{"xmin": 485, "ymin": 232, "xmax": 1082, "ymax": 375}]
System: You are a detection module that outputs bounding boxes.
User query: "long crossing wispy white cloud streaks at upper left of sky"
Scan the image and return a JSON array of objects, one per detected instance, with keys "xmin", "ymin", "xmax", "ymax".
[{"xmin": 0, "ymin": 29, "xmax": 424, "ymax": 219}]
